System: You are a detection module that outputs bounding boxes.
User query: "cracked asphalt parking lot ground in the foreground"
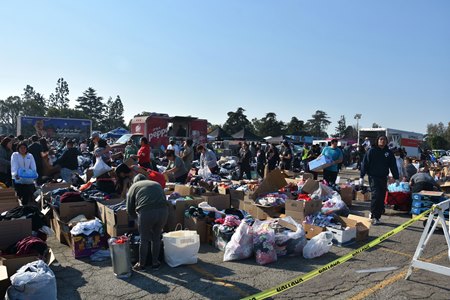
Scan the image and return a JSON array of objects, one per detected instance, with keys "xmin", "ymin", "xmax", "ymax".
[{"xmin": 49, "ymin": 170, "xmax": 450, "ymax": 299}]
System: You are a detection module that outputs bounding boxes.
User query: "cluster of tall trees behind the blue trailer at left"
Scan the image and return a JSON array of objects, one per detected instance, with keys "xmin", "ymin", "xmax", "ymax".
[{"xmin": 0, "ymin": 78, "xmax": 125, "ymax": 134}]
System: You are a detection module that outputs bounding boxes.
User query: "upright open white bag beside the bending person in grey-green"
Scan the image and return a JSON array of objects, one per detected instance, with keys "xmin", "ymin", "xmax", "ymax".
[{"xmin": 163, "ymin": 230, "xmax": 200, "ymax": 268}]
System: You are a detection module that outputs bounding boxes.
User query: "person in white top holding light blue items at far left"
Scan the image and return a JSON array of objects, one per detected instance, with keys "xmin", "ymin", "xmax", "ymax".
[{"xmin": 11, "ymin": 142, "xmax": 37, "ymax": 205}]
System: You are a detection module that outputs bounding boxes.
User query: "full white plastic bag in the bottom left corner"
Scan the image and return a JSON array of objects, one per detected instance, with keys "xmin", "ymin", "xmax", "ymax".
[{"xmin": 5, "ymin": 260, "xmax": 56, "ymax": 300}]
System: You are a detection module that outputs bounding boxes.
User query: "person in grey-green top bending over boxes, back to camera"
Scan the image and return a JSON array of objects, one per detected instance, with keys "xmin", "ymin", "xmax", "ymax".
[{"xmin": 126, "ymin": 174, "xmax": 169, "ymax": 271}]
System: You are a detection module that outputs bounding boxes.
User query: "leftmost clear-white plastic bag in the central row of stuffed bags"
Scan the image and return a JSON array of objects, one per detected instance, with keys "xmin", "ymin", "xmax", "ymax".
[{"xmin": 223, "ymin": 222, "xmax": 253, "ymax": 261}]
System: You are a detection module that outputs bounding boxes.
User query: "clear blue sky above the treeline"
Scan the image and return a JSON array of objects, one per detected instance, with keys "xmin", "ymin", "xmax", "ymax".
[{"xmin": 0, "ymin": 0, "xmax": 450, "ymax": 133}]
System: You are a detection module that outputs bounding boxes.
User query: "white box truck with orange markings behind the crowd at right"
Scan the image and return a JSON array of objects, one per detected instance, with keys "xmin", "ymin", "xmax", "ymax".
[{"xmin": 359, "ymin": 128, "xmax": 423, "ymax": 158}]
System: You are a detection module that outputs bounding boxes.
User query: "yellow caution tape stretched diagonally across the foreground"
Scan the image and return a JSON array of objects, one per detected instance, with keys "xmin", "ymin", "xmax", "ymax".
[{"xmin": 242, "ymin": 207, "xmax": 434, "ymax": 300}]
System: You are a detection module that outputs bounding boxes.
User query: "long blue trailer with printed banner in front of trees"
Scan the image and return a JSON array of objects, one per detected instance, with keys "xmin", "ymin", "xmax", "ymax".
[{"xmin": 17, "ymin": 116, "xmax": 92, "ymax": 139}]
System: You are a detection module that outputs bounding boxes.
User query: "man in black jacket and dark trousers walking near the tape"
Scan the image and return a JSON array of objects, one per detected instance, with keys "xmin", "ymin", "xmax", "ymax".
[{"xmin": 360, "ymin": 136, "xmax": 399, "ymax": 225}]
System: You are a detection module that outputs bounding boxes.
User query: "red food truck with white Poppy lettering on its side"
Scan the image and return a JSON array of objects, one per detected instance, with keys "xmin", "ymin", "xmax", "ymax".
[{"xmin": 112, "ymin": 113, "xmax": 208, "ymax": 152}]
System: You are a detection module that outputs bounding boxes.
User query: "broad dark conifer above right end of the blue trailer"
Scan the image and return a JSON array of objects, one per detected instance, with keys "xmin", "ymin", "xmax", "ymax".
[{"xmin": 75, "ymin": 87, "xmax": 106, "ymax": 130}]
